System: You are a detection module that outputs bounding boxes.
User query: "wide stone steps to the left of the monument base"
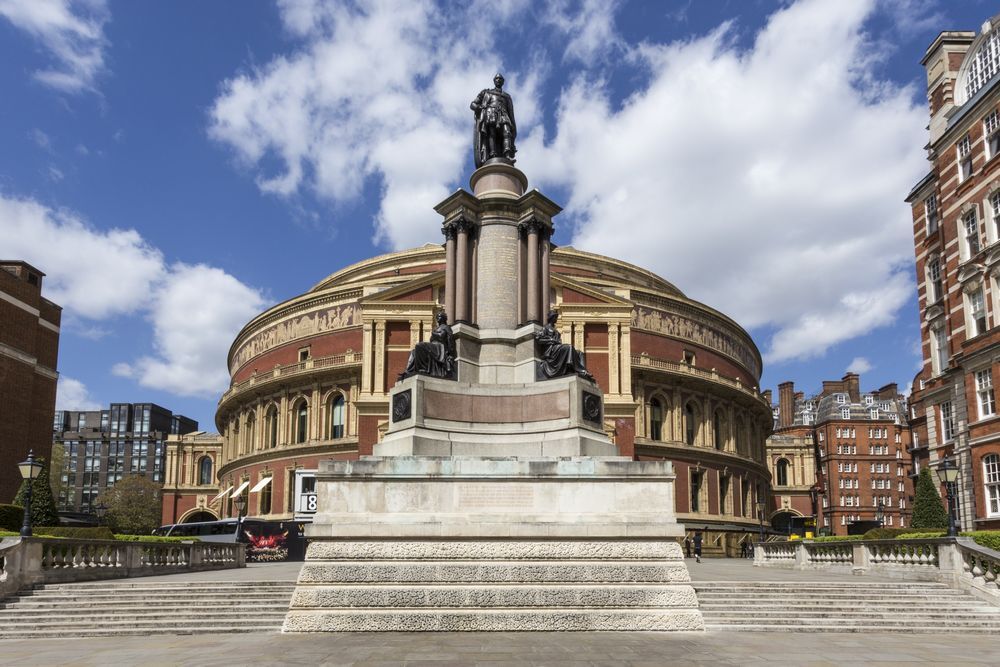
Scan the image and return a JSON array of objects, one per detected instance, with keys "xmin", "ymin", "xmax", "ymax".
[{"xmin": 0, "ymin": 580, "xmax": 295, "ymax": 639}]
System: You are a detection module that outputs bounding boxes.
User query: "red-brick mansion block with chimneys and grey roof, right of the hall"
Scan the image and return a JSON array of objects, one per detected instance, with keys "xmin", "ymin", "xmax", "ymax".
[{"xmin": 767, "ymin": 373, "xmax": 913, "ymax": 535}]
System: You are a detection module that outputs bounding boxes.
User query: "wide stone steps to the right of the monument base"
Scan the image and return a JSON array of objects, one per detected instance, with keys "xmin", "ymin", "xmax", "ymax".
[{"xmin": 694, "ymin": 581, "xmax": 1000, "ymax": 633}]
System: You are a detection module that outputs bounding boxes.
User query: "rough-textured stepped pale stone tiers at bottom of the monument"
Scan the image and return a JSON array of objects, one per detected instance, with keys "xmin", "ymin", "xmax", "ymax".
[{"xmin": 284, "ymin": 540, "xmax": 704, "ymax": 632}]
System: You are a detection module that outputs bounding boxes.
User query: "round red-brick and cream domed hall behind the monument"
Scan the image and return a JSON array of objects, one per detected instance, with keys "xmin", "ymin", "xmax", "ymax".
[{"xmin": 193, "ymin": 240, "xmax": 772, "ymax": 554}]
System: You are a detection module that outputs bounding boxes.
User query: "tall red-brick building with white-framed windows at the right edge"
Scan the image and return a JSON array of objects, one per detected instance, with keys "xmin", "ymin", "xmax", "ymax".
[{"xmin": 906, "ymin": 15, "xmax": 1000, "ymax": 530}]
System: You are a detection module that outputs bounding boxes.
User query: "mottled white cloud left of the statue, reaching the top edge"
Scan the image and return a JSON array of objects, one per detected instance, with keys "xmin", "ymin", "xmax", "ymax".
[{"xmin": 209, "ymin": 0, "xmax": 537, "ymax": 248}]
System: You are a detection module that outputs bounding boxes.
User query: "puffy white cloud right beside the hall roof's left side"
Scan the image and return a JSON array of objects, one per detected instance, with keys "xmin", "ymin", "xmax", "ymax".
[{"xmin": 112, "ymin": 263, "xmax": 265, "ymax": 397}]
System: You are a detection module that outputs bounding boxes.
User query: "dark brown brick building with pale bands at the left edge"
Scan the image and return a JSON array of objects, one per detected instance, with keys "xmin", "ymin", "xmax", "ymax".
[{"xmin": 0, "ymin": 260, "xmax": 62, "ymax": 503}]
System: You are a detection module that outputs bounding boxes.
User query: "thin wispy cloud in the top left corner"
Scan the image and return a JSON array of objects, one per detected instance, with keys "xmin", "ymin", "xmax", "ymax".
[{"xmin": 0, "ymin": 0, "xmax": 111, "ymax": 93}]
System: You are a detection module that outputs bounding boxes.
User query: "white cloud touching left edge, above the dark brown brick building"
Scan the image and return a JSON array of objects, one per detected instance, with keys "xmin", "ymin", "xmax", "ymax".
[{"xmin": 0, "ymin": 195, "xmax": 165, "ymax": 320}]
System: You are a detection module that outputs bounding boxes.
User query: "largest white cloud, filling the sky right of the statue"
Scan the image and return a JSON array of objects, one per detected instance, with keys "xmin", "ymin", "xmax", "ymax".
[{"xmin": 520, "ymin": 0, "xmax": 926, "ymax": 362}]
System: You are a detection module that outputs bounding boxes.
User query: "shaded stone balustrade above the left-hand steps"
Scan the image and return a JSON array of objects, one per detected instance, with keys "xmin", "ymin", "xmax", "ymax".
[{"xmin": 0, "ymin": 537, "xmax": 246, "ymax": 599}]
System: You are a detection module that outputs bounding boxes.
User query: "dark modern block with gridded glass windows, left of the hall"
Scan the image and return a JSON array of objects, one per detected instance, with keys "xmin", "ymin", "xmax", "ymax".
[{"xmin": 49, "ymin": 403, "xmax": 198, "ymax": 515}]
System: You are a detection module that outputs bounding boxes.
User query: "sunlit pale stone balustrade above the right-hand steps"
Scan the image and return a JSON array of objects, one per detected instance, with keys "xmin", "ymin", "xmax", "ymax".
[{"xmin": 754, "ymin": 537, "xmax": 1000, "ymax": 605}]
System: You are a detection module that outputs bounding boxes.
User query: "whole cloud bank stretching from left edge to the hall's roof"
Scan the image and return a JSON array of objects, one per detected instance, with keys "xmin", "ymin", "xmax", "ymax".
[{"xmin": 0, "ymin": 195, "xmax": 265, "ymax": 398}]
